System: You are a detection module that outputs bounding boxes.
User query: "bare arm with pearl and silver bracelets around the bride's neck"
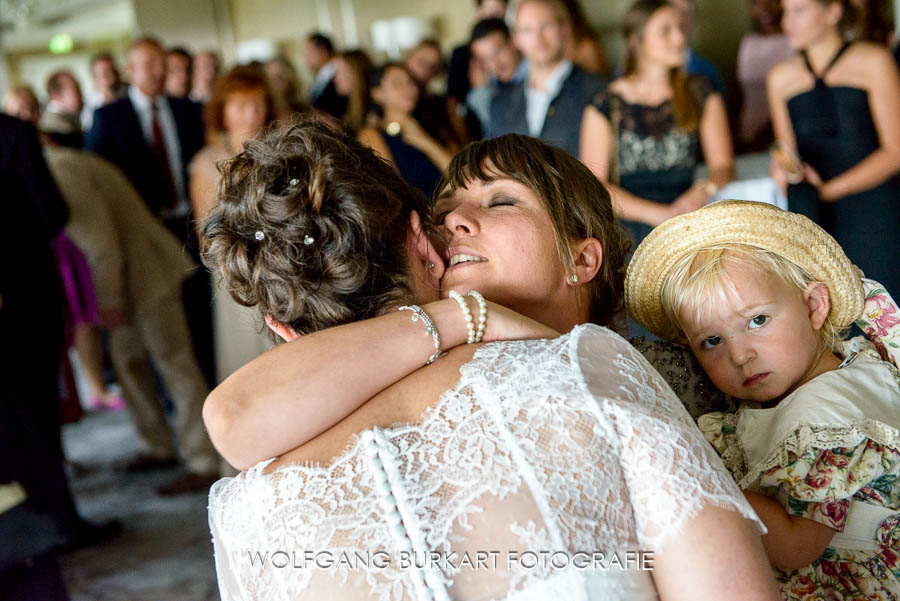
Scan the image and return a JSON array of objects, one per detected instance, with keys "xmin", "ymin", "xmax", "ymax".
[{"xmin": 203, "ymin": 299, "xmax": 556, "ymax": 469}]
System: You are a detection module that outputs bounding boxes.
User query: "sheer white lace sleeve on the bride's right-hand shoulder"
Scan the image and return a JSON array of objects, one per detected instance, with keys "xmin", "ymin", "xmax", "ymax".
[{"xmin": 577, "ymin": 328, "xmax": 765, "ymax": 549}]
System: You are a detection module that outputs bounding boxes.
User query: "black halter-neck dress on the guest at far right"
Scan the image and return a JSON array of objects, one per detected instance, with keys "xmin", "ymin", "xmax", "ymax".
[{"xmin": 787, "ymin": 43, "xmax": 900, "ymax": 295}]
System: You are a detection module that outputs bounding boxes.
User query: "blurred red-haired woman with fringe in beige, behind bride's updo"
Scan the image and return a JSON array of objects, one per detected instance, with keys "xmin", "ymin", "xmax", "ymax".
[{"xmin": 189, "ymin": 67, "xmax": 275, "ymax": 382}]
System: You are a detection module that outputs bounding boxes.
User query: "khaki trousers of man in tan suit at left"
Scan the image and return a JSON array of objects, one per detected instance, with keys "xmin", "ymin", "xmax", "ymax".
[{"xmin": 110, "ymin": 289, "xmax": 221, "ymax": 475}]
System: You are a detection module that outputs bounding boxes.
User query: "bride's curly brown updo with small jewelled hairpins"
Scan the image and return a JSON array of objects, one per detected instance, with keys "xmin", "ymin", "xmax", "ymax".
[{"xmin": 201, "ymin": 117, "xmax": 427, "ymax": 334}]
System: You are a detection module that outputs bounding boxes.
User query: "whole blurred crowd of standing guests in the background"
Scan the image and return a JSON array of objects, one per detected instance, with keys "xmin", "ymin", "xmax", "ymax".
[{"xmin": 0, "ymin": 0, "xmax": 900, "ymax": 586}]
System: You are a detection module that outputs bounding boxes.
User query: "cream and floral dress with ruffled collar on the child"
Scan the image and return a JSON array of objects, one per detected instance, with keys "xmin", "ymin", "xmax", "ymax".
[{"xmin": 698, "ymin": 337, "xmax": 900, "ymax": 601}]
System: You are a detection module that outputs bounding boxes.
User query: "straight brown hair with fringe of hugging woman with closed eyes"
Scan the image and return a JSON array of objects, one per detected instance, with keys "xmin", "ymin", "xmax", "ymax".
[{"xmin": 437, "ymin": 134, "xmax": 631, "ymax": 326}]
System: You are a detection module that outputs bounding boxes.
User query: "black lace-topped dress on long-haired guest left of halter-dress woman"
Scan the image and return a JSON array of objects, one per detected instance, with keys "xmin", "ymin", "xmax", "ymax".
[{"xmin": 592, "ymin": 75, "xmax": 715, "ymax": 246}]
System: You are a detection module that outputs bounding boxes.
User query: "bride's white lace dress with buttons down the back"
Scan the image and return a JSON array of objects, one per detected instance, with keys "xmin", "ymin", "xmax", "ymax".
[{"xmin": 209, "ymin": 326, "xmax": 764, "ymax": 601}]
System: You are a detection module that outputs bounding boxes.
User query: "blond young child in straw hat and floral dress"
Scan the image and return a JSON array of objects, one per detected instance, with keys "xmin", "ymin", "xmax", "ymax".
[{"xmin": 625, "ymin": 201, "xmax": 900, "ymax": 601}]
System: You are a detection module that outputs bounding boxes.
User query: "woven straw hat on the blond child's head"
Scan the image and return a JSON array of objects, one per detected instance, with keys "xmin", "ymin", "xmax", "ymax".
[{"xmin": 625, "ymin": 200, "xmax": 865, "ymax": 338}]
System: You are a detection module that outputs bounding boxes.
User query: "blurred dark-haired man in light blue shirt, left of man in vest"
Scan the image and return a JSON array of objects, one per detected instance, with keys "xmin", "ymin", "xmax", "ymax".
[{"xmin": 466, "ymin": 19, "xmax": 528, "ymax": 131}]
